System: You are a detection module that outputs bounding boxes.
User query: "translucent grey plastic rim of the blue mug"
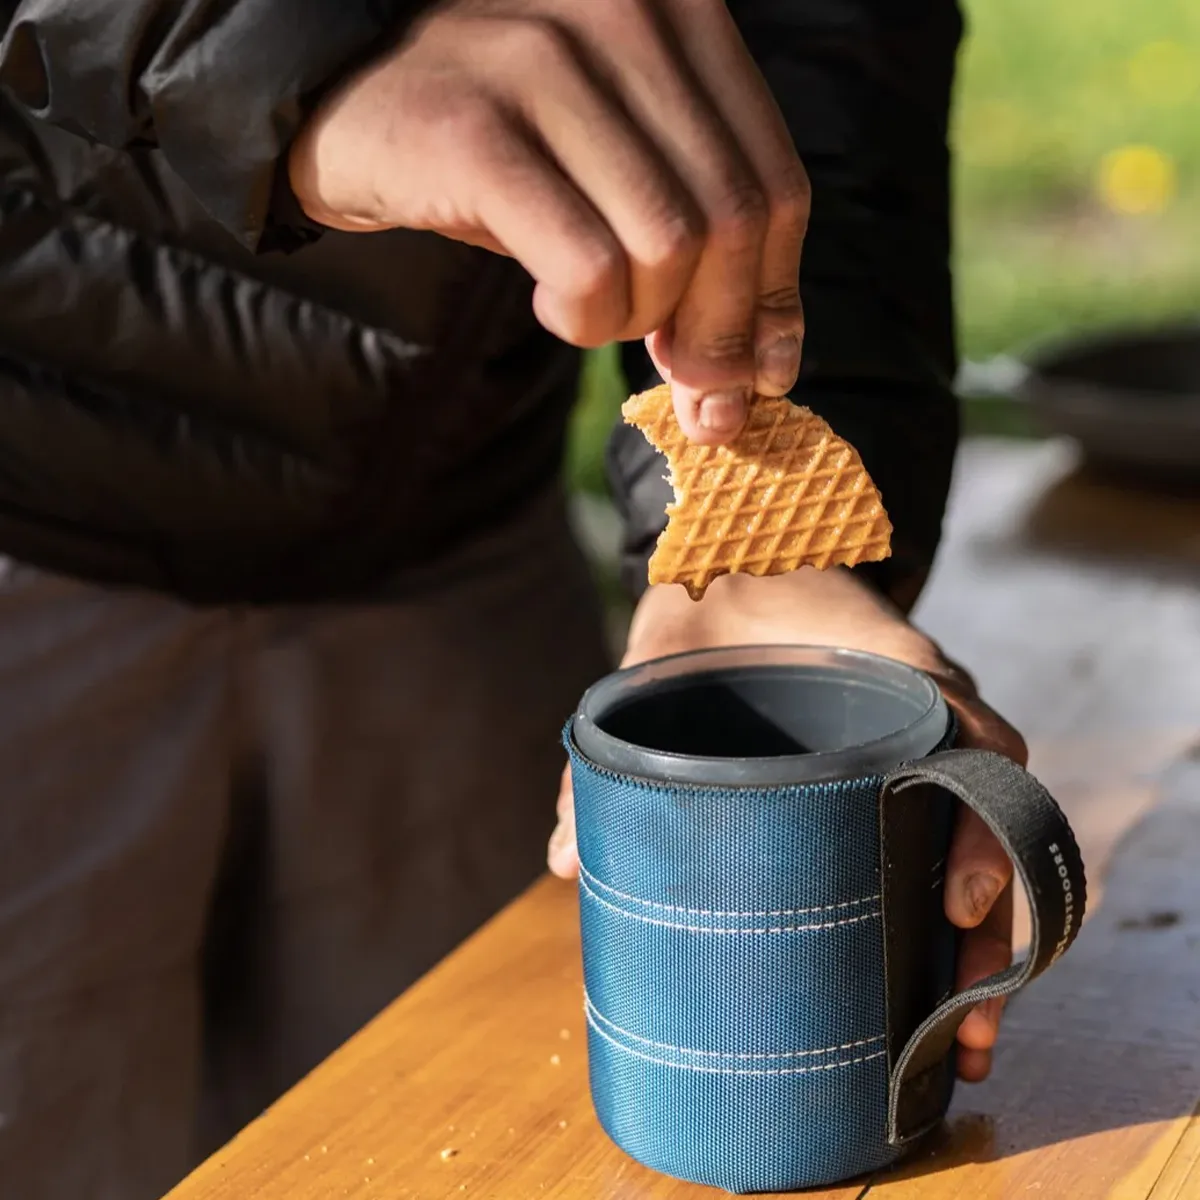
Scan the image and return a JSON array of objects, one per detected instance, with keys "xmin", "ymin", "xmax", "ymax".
[{"xmin": 571, "ymin": 643, "xmax": 950, "ymax": 787}]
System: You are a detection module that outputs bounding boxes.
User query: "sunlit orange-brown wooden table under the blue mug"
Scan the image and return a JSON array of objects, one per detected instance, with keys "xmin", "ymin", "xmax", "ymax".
[{"xmin": 169, "ymin": 443, "xmax": 1200, "ymax": 1200}]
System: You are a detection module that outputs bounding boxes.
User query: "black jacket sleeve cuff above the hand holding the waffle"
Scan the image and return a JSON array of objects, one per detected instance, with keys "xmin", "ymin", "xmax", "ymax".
[{"xmin": 0, "ymin": 0, "xmax": 420, "ymax": 250}]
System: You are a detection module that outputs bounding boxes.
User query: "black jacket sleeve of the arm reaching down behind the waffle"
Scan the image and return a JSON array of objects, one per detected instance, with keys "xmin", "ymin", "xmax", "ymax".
[{"xmin": 608, "ymin": 0, "xmax": 961, "ymax": 610}]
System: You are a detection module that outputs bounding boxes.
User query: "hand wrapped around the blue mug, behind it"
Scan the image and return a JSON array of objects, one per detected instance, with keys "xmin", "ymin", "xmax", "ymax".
[{"xmin": 548, "ymin": 569, "xmax": 1026, "ymax": 1081}]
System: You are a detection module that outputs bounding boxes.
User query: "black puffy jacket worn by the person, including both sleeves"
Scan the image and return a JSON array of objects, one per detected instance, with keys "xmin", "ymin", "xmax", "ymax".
[{"xmin": 0, "ymin": 0, "xmax": 960, "ymax": 604}]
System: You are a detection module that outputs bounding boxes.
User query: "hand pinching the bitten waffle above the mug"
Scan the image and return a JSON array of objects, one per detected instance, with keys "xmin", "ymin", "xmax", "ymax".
[{"xmin": 288, "ymin": 0, "xmax": 809, "ymax": 444}]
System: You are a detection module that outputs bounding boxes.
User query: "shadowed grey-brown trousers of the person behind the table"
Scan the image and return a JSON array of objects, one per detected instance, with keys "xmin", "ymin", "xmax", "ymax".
[{"xmin": 0, "ymin": 497, "xmax": 606, "ymax": 1200}]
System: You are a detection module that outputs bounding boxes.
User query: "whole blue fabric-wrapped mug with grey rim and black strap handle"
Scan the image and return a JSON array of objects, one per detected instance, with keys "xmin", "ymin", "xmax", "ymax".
[{"xmin": 564, "ymin": 646, "xmax": 1086, "ymax": 1193}]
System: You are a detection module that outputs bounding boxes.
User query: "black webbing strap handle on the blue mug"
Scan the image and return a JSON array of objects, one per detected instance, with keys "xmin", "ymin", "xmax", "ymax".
[{"xmin": 880, "ymin": 750, "xmax": 1086, "ymax": 1146}]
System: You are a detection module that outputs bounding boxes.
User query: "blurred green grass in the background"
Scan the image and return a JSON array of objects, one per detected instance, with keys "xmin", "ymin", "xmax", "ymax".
[{"xmin": 568, "ymin": 0, "xmax": 1200, "ymax": 492}]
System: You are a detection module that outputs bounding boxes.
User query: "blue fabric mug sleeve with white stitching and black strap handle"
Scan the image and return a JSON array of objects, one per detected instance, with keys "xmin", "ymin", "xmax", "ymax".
[{"xmin": 564, "ymin": 727, "xmax": 1085, "ymax": 1193}]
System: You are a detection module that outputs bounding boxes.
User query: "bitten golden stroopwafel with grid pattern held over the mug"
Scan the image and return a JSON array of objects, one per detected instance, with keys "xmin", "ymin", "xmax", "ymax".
[{"xmin": 622, "ymin": 384, "xmax": 892, "ymax": 600}]
